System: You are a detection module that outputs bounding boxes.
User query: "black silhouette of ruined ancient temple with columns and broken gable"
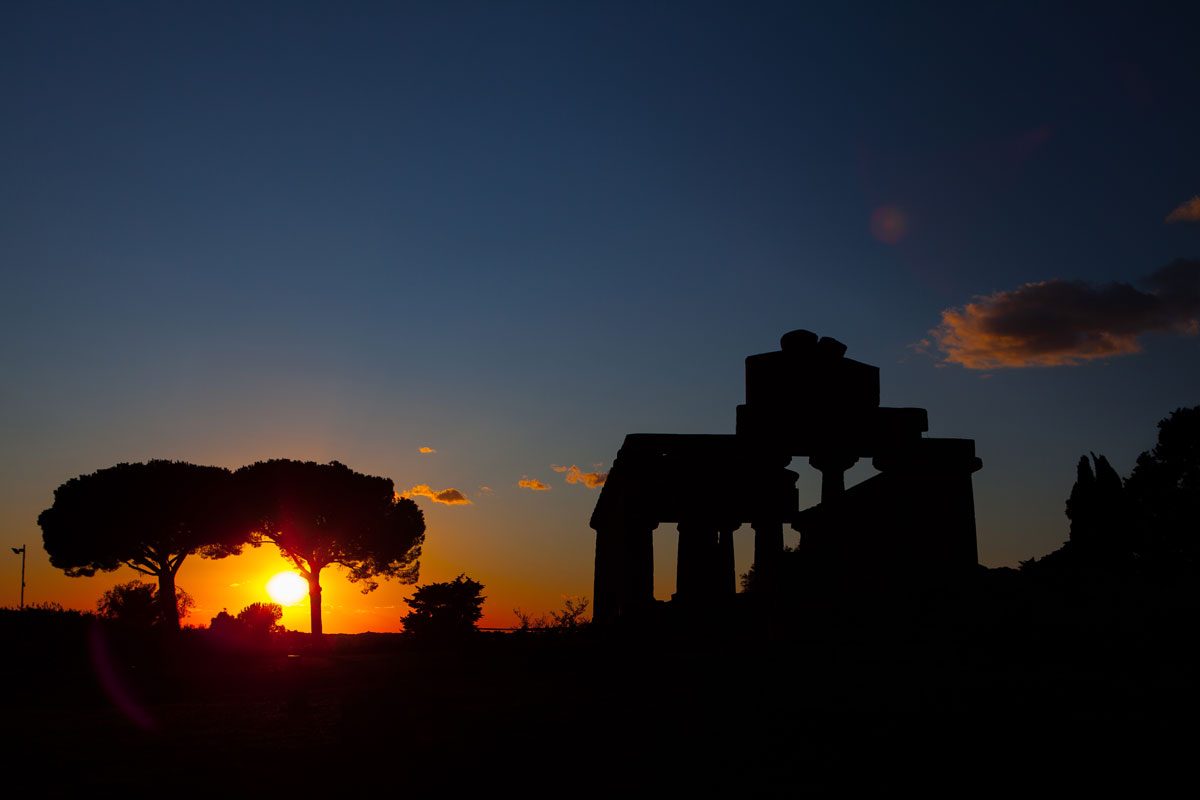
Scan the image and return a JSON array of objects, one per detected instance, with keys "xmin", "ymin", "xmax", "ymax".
[{"xmin": 590, "ymin": 331, "xmax": 982, "ymax": 622}]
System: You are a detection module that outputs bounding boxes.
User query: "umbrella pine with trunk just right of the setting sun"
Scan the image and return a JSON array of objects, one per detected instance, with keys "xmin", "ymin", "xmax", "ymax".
[{"xmin": 234, "ymin": 459, "xmax": 425, "ymax": 637}]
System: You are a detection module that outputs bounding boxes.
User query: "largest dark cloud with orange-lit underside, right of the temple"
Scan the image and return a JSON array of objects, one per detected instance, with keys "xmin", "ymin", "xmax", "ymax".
[{"xmin": 923, "ymin": 259, "xmax": 1200, "ymax": 369}]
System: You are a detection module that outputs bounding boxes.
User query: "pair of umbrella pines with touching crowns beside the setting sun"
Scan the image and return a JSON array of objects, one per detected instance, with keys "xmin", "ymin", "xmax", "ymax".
[{"xmin": 37, "ymin": 459, "xmax": 425, "ymax": 636}]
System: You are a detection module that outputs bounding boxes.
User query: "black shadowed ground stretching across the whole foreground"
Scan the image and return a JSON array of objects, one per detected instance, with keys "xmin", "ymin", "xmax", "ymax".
[{"xmin": 0, "ymin": 575, "xmax": 1200, "ymax": 796}]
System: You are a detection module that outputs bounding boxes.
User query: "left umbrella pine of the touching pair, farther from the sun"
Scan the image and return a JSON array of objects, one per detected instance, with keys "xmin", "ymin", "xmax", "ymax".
[{"xmin": 37, "ymin": 461, "xmax": 240, "ymax": 630}]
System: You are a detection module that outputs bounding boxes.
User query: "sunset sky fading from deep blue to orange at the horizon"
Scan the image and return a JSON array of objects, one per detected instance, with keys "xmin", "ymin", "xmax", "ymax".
[{"xmin": 0, "ymin": 1, "xmax": 1200, "ymax": 632}]
